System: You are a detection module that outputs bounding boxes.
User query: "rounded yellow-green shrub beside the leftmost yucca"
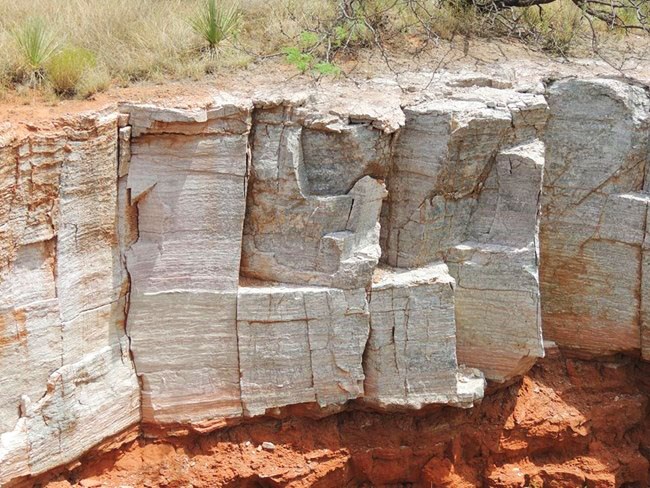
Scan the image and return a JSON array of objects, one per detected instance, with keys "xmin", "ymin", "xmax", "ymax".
[{"xmin": 46, "ymin": 46, "xmax": 97, "ymax": 95}]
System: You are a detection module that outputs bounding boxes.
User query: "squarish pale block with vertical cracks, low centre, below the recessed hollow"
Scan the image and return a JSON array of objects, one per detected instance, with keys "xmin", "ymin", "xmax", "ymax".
[{"xmin": 237, "ymin": 285, "xmax": 368, "ymax": 416}]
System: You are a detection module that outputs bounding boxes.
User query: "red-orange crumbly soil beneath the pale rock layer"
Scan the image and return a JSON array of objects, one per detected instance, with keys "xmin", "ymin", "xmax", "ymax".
[{"xmin": 39, "ymin": 346, "xmax": 650, "ymax": 488}]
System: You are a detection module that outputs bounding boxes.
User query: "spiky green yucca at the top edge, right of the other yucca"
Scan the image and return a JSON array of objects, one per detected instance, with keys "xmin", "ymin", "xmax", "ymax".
[{"xmin": 190, "ymin": 0, "xmax": 242, "ymax": 55}]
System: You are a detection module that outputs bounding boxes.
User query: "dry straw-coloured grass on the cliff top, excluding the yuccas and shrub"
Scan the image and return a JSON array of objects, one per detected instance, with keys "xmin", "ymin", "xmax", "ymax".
[{"xmin": 0, "ymin": 0, "xmax": 640, "ymax": 96}]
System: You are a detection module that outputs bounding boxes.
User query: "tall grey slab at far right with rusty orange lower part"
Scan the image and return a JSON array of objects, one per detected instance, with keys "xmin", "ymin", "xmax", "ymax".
[{"xmin": 540, "ymin": 79, "xmax": 650, "ymax": 356}]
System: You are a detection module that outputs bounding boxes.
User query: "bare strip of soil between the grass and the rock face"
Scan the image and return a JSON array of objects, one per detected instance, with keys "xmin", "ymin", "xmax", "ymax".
[{"xmin": 0, "ymin": 35, "xmax": 650, "ymax": 137}]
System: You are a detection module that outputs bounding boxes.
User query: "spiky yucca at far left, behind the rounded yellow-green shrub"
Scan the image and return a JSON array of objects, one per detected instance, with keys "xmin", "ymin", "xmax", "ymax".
[{"xmin": 13, "ymin": 18, "xmax": 60, "ymax": 85}]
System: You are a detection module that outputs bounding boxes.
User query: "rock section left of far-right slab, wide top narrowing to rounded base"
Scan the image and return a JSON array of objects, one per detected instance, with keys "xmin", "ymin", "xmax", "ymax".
[{"xmin": 382, "ymin": 88, "xmax": 547, "ymax": 381}]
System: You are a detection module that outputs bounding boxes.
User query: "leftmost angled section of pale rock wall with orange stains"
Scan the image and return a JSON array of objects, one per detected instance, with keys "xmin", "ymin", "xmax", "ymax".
[{"xmin": 0, "ymin": 114, "xmax": 140, "ymax": 485}]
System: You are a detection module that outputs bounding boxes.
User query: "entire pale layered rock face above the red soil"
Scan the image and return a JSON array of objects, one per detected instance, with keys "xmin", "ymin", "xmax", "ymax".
[{"xmin": 0, "ymin": 75, "xmax": 650, "ymax": 484}]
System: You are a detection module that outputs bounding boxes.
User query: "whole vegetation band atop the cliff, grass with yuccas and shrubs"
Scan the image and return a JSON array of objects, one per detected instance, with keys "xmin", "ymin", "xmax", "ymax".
[{"xmin": 0, "ymin": 0, "xmax": 640, "ymax": 97}]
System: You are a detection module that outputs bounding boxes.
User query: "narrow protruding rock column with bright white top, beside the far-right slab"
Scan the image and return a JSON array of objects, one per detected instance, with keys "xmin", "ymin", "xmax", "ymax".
[{"xmin": 447, "ymin": 141, "xmax": 544, "ymax": 381}]
